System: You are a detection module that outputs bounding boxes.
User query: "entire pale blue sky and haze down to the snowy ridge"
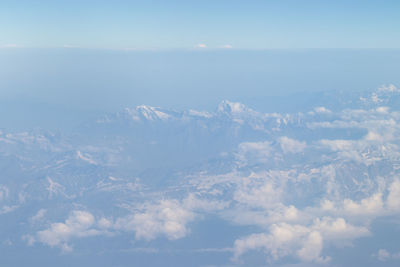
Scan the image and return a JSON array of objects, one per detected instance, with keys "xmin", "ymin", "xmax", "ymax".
[{"xmin": 0, "ymin": 0, "xmax": 400, "ymax": 131}]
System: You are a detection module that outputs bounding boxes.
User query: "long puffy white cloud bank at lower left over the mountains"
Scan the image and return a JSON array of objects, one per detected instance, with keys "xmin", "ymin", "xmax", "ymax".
[{"xmin": 30, "ymin": 194, "xmax": 219, "ymax": 252}]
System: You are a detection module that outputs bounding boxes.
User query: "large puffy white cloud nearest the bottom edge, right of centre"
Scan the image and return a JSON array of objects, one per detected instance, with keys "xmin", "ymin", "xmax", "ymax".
[{"xmin": 233, "ymin": 217, "xmax": 369, "ymax": 263}]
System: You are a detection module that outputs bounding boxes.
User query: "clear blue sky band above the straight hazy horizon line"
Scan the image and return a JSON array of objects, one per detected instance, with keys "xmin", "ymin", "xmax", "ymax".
[{"xmin": 0, "ymin": 0, "xmax": 400, "ymax": 50}]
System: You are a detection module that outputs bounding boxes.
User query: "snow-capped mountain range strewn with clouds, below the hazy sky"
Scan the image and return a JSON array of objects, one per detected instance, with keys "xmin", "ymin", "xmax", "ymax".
[{"xmin": 0, "ymin": 86, "xmax": 400, "ymax": 266}]
